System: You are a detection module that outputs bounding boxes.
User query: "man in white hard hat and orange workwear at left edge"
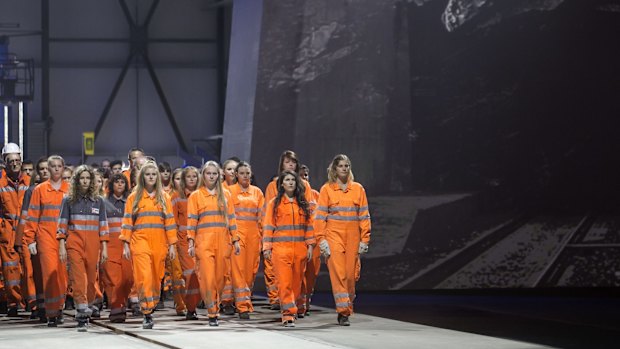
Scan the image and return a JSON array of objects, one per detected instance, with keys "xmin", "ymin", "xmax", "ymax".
[{"xmin": 0, "ymin": 143, "xmax": 30, "ymax": 316}]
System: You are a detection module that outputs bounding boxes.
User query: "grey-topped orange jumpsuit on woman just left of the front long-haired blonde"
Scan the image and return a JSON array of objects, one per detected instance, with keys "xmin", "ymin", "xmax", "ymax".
[{"xmin": 101, "ymin": 195, "xmax": 133, "ymax": 321}]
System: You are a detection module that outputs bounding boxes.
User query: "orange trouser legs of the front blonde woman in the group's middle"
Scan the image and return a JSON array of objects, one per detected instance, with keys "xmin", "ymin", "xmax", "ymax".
[{"xmin": 195, "ymin": 232, "xmax": 232, "ymax": 318}]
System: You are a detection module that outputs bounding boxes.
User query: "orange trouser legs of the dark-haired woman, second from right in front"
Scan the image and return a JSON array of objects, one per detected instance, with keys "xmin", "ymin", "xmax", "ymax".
[{"xmin": 271, "ymin": 242, "xmax": 308, "ymax": 321}]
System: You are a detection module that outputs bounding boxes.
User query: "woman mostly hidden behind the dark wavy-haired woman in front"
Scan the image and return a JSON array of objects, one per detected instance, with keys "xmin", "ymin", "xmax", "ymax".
[{"xmin": 263, "ymin": 150, "xmax": 315, "ymax": 314}]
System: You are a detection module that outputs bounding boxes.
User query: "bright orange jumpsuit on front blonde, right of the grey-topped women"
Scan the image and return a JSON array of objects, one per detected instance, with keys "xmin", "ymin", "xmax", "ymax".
[{"xmin": 119, "ymin": 191, "xmax": 177, "ymax": 315}]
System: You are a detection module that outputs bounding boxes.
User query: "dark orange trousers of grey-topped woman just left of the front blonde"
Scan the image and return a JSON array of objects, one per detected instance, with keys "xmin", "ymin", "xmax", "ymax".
[{"xmin": 101, "ymin": 233, "xmax": 133, "ymax": 320}]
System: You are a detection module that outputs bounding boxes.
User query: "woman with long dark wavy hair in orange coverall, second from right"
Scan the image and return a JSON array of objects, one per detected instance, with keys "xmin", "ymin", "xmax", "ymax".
[{"xmin": 263, "ymin": 171, "xmax": 316, "ymax": 327}]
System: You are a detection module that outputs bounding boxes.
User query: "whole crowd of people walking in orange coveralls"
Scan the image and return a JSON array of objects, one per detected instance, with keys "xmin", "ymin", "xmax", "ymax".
[{"xmin": 0, "ymin": 143, "xmax": 371, "ymax": 331}]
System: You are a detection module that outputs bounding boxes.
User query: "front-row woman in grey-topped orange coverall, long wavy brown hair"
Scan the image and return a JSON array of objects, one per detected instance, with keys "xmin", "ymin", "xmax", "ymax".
[{"xmin": 56, "ymin": 165, "xmax": 110, "ymax": 332}]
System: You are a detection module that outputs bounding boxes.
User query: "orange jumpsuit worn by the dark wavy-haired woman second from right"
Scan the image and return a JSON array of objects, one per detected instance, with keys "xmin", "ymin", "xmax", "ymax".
[{"xmin": 263, "ymin": 197, "xmax": 316, "ymax": 322}]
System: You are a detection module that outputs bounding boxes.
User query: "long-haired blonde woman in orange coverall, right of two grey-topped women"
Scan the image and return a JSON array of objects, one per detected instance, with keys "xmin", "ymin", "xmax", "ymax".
[{"xmin": 120, "ymin": 161, "xmax": 177, "ymax": 329}]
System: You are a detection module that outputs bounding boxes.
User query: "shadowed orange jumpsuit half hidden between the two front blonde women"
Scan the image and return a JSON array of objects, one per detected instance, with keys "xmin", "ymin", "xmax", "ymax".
[{"xmin": 172, "ymin": 190, "xmax": 200, "ymax": 312}]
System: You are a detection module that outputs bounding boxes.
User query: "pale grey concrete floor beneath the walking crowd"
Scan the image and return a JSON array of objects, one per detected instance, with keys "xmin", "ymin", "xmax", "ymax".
[{"xmin": 0, "ymin": 301, "xmax": 552, "ymax": 349}]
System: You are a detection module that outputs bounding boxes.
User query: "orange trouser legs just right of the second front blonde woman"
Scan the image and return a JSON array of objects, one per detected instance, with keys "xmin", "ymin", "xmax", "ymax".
[{"xmin": 231, "ymin": 244, "xmax": 258, "ymax": 313}]
